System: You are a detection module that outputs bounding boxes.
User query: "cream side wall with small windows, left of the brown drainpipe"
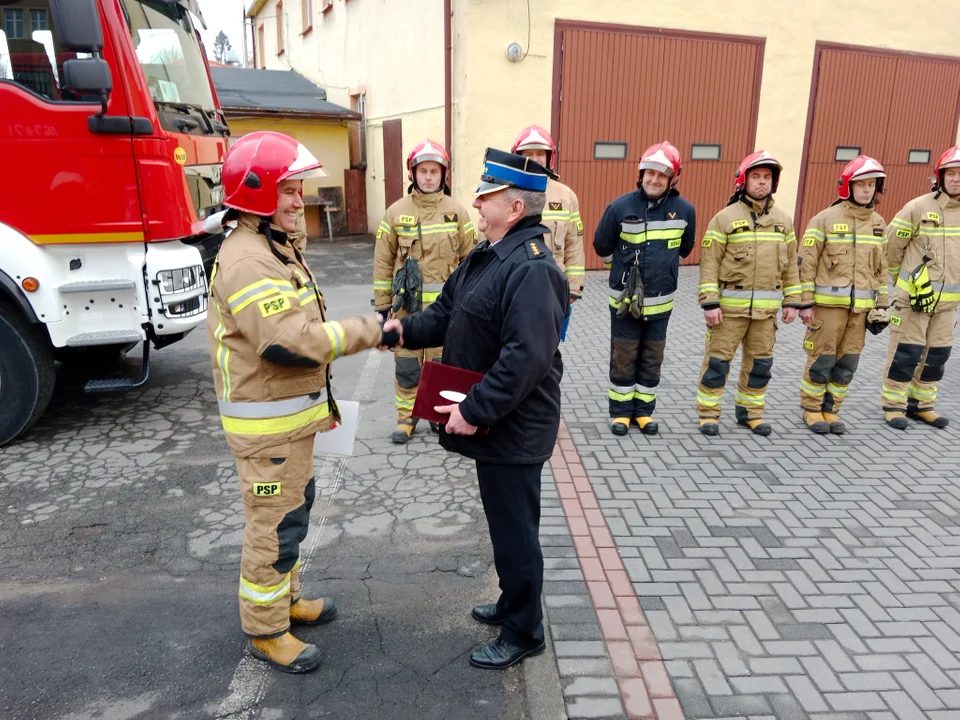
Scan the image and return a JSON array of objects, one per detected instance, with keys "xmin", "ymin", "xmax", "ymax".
[{"xmin": 253, "ymin": 0, "xmax": 444, "ymax": 228}]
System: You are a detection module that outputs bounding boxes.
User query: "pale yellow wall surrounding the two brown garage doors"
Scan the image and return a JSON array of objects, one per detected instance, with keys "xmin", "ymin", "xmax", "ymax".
[{"xmin": 448, "ymin": 0, "xmax": 960, "ymax": 222}]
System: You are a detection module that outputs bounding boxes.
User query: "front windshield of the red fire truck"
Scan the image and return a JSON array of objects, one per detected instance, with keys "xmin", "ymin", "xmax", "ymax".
[{"xmin": 123, "ymin": 0, "xmax": 214, "ymax": 112}]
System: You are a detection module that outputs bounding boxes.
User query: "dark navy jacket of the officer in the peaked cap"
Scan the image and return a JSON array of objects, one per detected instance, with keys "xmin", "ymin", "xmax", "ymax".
[{"xmin": 401, "ymin": 216, "xmax": 570, "ymax": 465}]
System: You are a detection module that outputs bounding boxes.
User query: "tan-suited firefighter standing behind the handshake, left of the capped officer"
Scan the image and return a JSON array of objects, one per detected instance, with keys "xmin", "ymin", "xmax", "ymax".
[{"xmin": 373, "ymin": 140, "xmax": 477, "ymax": 445}]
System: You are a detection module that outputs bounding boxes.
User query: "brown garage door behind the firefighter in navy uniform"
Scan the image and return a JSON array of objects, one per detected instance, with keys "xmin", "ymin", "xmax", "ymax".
[{"xmin": 553, "ymin": 21, "xmax": 763, "ymax": 269}]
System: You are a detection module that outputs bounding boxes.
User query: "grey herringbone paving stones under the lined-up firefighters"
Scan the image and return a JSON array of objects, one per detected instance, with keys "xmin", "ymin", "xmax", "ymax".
[{"xmin": 556, "ymin": 268, "xmax": 960, "ymax": 720}]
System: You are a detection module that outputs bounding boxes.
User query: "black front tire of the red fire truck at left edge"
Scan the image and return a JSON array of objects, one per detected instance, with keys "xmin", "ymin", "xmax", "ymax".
[{"xmin": 0, "ymin": 305, "xmax": 56, "ymax": 446}]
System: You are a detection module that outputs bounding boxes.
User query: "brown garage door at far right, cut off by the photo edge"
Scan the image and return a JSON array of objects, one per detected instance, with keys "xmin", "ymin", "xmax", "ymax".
[{"xmin": 796, "ymin": 43, "xmax": 960, "ymax": 227}]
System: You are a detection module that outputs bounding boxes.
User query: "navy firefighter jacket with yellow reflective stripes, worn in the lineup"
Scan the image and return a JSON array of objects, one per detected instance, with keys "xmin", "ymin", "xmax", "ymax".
[{"xmin": 593, "ymin": 188, "xmax": 697, "ymax": 307}]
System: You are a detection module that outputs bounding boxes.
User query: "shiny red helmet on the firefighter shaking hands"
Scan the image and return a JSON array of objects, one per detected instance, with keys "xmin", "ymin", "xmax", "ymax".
[{"xmin": 222, "ymin": 130, "xmax": 327, "ymax": 216}]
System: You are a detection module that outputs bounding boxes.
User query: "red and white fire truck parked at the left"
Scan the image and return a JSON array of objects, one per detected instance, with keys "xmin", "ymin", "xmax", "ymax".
[{"xmin": 0, "ymin": 0, "xmax": 229, "ymax": 445}]
